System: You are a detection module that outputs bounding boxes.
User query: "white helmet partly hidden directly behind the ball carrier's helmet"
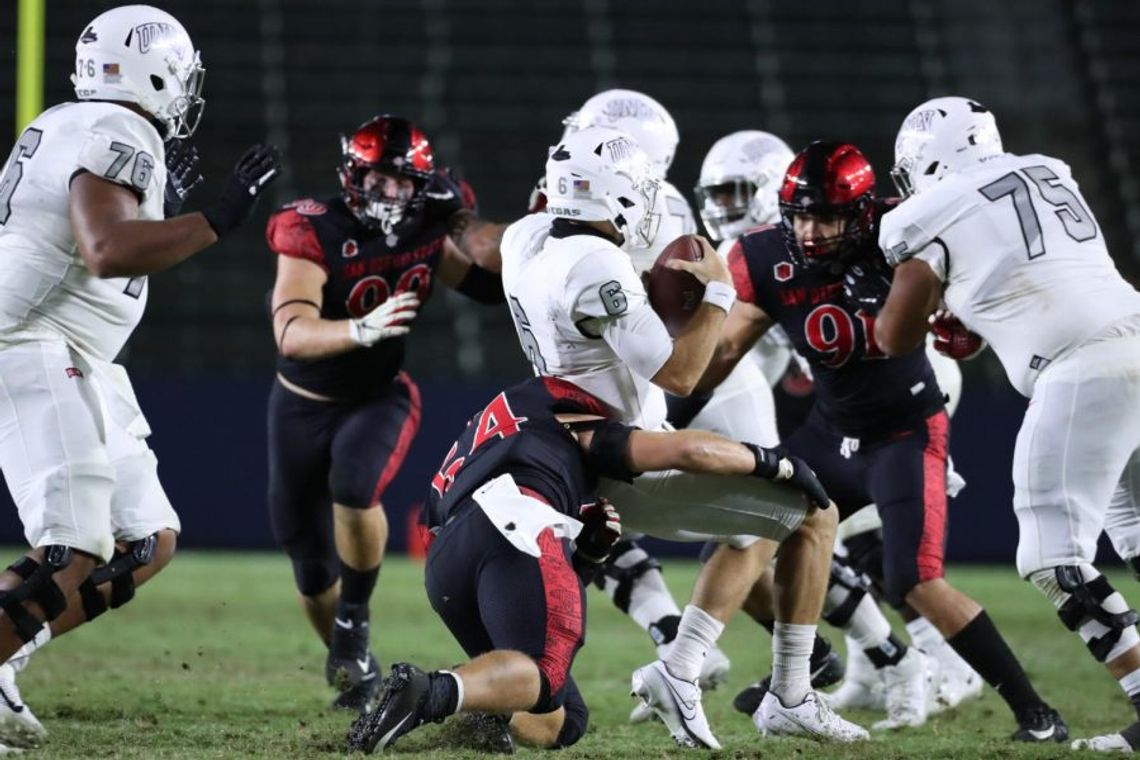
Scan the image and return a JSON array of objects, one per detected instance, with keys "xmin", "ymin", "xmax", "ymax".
[{"xmin": 562, "ymin": 90, "xmax": 681, "ymax": 180}]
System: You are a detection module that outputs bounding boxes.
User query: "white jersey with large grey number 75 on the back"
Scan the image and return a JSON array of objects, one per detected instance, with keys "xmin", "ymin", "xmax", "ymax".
[{"xmin": 879, "ymin": 154, "xmax": 1140, "ymax": 397}]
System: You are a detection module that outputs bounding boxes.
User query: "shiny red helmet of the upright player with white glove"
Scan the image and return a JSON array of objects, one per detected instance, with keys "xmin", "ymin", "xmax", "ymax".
[{"xmin": 337, "ymin": 114, "xmax": 435, "ymax": 234}]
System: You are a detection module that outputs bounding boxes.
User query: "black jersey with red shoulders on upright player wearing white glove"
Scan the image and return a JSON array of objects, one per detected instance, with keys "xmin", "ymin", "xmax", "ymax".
[{"xmin": 266, "ymin": 196, "xmax": 448, "ymax": 400}]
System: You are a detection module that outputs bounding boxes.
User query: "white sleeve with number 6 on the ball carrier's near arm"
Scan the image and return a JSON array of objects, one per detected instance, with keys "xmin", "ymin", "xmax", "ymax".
[{"xmin": 567, "ymin": 246, "xmax": 673, "ymax": 379}]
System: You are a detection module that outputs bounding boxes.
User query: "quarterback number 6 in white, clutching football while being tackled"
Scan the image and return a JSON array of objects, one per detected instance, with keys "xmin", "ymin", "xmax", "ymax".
[{"xmin": 502, "ymin": 126, "xmax": 866, "ymax": 749}]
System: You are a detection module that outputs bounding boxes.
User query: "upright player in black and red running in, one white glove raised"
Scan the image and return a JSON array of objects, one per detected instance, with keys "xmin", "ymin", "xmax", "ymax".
[{"xmin": 266, "ymin": 115, "xmax": 504, "ymax": 710}]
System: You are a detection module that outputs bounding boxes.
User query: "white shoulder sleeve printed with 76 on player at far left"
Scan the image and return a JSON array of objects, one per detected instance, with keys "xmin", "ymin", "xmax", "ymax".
[{"xmin": 78, "ymin": 112, "xmax": 166, "ymax": 199}]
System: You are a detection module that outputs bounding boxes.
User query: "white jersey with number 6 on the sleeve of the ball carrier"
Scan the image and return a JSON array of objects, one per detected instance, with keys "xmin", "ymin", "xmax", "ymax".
[{"xmin": 500, "ymin": 213, "xmax": 673, "ymax": 430}]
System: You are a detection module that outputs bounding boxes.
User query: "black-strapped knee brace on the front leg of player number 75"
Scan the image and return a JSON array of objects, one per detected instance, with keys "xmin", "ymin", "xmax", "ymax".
[{"xmin": 1029, "ymin": 564, "xmax": 1140, "ymax": 662}]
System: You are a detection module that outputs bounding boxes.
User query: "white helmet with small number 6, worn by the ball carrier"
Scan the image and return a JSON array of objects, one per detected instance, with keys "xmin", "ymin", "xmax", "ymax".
[{"xmin": 546, "ymin": 126, "xmax": 661, "ymax": 251}]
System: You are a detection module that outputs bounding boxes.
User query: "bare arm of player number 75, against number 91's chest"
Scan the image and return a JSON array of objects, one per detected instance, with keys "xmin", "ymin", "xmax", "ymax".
[{"xmin": 874, "ymin": 259, "xmax": 942, "ymax": 357}]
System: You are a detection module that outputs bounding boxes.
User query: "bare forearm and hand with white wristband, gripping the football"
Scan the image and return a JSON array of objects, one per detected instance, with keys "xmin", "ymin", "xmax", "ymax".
[{"xmin": 650, "ymin": 236, "xmax": 735, "ymax": 397}]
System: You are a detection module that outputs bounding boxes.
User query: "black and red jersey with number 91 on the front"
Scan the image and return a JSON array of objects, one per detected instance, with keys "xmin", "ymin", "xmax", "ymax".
[{"xmin": 728, "ymin": 213, "xmax": 944, "ymax": 439}]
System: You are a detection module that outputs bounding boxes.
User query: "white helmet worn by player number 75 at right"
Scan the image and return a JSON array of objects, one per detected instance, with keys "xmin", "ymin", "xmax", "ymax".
[{"xmin": 890, "ymin": 97, "xmax": 1004, "ymax": 198}]
